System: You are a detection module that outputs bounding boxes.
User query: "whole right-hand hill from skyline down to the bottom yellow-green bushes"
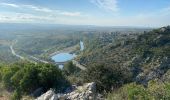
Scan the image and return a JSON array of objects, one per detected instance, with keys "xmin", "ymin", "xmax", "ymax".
[{"xmin": 77, "ymin": 26, "xmax": 170, "ymax": 100}]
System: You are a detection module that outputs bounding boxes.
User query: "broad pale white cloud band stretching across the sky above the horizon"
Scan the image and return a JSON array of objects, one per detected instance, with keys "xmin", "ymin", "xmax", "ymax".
[{"xmin": 0, "ymin": 4, "xmax": 170, "ymax": 27}]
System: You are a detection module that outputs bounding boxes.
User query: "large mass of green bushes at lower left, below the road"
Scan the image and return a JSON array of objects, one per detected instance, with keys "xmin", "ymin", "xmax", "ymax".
[{"xmin": 0, "ymin": 63, "xmax": 69, "ymax": 100}]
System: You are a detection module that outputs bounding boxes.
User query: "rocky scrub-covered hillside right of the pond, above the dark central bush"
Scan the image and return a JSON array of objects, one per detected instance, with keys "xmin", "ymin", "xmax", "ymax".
[{"xmin": 79, "ymin": 26, "xmax": 170, "ymax": 85}]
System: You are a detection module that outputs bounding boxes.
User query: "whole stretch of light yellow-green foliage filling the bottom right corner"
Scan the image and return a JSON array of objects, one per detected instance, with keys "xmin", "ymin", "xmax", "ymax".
[{"xmin": 107, "ymin": 80, "xmax": 170, "ymax": 100}]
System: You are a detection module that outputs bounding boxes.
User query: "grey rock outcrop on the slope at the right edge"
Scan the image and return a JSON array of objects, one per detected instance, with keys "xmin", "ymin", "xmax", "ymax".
[{"xmin": 136, "ymin": 57, "xmax": 170, "ymax": 86}]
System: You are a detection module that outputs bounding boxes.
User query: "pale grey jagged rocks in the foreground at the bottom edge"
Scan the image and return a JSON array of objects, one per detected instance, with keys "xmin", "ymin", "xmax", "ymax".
[{"xmin": 36, "ymin": 82, "xmax": 102, "ymax": 100}]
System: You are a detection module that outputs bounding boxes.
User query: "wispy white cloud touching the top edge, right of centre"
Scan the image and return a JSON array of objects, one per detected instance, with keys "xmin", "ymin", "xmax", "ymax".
[{"xmin": 91, "ymin": 0, "xmax": 118, "ymax": 12}]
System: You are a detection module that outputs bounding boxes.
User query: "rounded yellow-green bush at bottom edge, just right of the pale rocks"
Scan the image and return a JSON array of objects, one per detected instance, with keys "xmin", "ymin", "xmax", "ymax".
[{"xmin": 107, "ymin": 83, "xmax": 154, "ymax": 100}]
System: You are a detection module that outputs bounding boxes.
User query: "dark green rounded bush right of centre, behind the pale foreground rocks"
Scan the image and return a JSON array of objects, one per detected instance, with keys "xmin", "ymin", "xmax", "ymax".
[{"xmin": 84, "ymin": 65, "xmax": 131, "ymax": 92}]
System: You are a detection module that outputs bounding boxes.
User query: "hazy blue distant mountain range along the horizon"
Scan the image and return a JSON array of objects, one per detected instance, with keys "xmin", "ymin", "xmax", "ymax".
[{"xmin": 0, "ymin": 23, "xmax": 152, "ymax": 30}]
